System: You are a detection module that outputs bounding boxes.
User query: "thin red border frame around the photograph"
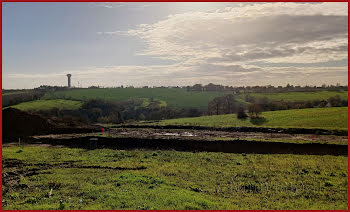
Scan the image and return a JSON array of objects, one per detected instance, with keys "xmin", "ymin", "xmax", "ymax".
[{"xmin": 0, "ymin": 0, "xmax": 350, "ymax": 212}]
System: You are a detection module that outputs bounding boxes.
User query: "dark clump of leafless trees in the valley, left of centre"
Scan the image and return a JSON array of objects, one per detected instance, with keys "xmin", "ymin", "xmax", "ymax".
[{"xmin": 39, "ymin": 99, "xmax": 204, "ymax": 124}]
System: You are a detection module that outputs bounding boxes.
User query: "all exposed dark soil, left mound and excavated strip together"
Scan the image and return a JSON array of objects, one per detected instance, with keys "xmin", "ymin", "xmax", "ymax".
[{"xmin": 3, "ymin": 108, "xmax": 347, "ymax": 157}]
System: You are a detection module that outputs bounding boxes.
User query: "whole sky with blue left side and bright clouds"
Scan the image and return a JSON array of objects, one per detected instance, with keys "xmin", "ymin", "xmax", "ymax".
[{"xmin": 2, "ymin": 2, "xmax": 348, "ymax": 89}]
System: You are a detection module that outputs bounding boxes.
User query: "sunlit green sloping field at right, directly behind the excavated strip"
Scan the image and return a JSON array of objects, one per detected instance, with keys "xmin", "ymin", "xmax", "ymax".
[{"xmin": 158, "ymin": 107, "xmax": 348, "ymax": 130}]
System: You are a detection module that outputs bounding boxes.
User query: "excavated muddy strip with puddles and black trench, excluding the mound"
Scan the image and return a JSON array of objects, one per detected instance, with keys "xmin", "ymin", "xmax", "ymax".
[{"xmin": 4, "ymin": 128, "xmax": 347, "ymax": 155}]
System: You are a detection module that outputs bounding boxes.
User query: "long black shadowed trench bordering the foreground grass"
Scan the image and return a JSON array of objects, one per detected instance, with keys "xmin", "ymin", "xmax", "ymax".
[{"xmin": 25, "ymin": 136, "xmax": 348, "ymax": 155}]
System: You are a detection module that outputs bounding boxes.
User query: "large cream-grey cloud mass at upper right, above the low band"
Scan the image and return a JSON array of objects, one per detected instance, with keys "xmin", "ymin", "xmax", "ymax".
[{"xmin": 119, "ymin": 3, "xmax": 348, "ymax": 62}]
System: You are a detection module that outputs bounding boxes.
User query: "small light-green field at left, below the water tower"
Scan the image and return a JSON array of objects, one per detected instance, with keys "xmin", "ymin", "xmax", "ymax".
[{"xmin": 11, "ymin": 99, "xmax": 82, "ymax": 111}]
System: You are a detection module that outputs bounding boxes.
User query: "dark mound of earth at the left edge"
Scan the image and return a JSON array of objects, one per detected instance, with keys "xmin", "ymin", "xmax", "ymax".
[{"xmin": 2, "ymin": 108, "xmax": 101, "ymax": 139}]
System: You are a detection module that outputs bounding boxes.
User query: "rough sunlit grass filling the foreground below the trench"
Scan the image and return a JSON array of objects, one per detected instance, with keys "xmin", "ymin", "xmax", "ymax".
[{"xmin": 3, "ymin": 146, "xmax": 348, "ymax": 209}]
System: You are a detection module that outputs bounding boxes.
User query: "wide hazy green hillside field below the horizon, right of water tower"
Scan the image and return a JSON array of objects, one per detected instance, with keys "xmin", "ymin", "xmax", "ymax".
[{"xmin": 42, "ymin": 88, "xmax": 231, "ymax": 109}]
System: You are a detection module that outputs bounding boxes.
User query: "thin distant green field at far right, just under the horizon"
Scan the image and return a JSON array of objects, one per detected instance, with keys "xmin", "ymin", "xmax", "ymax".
[{"xmin": 240, "ymin": 91, "xmax": 348, "ymax": 102}]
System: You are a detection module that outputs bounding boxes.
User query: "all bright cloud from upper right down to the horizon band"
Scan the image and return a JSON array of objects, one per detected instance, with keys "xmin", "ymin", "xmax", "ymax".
[{"xmin": 4, "ymin": 2, "xmax": 348, "ymax": 86}]
